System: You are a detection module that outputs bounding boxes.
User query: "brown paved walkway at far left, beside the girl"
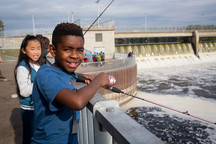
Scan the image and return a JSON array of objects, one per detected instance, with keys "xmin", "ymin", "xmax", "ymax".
[{"xmin": 0, "ymin": 62, "xmax": 22, "ymax": 144}]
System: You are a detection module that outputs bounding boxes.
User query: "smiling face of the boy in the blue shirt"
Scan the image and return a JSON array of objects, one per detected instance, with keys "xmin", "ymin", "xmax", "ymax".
[{"xmin": 53, "ymin": 35, "xmax": 84, "ymax": 73}]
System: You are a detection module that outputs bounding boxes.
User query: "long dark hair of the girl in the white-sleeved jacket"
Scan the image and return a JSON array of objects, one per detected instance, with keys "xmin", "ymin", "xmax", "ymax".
[{"xmin": 14, "ymin": 35, "xmax": 40, "ymax": 97}]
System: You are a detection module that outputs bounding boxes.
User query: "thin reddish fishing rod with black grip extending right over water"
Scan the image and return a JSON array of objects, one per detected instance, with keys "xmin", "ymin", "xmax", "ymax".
[{"xmin": 77, "ymin": 76, "xmax": 216, "ymax": 125}]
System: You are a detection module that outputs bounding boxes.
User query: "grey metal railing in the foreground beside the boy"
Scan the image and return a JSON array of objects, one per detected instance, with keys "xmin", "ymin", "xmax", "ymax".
[{"xmin": 75, "ymin": 83, "xmax": 164, "ymax": 144}]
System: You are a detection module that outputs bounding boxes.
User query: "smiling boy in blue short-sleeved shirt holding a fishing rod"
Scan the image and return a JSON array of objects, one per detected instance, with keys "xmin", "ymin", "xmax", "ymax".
[{"xmin": 32, "ymin": 23, "xmax": 111, "ymax": 144}]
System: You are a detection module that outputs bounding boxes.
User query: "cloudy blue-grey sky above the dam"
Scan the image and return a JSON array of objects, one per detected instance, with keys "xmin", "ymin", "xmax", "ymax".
[{"xmin": 0, "ymin": 0, "xmax": 216, "ymax": 30}]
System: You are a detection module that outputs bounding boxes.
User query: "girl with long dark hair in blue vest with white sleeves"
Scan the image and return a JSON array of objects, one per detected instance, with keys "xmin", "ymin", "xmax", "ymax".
[{"xmin": 14, "ymin": 35, "xmax": 41, "ymax": 144}]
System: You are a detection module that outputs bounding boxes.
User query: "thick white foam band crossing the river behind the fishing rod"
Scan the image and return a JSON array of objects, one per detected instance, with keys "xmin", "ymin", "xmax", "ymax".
[{"xmin": 121, "ymin": 91, "xmax": 216, "ymax": 123}]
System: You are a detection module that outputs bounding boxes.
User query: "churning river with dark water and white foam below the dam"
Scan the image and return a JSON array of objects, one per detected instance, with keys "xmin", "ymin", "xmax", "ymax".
[{"xmin": 122, "ymin": 62, "xmax": 216, "ymax": 144}]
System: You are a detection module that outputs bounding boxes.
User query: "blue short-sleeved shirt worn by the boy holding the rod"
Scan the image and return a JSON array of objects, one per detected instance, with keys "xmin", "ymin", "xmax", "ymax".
[{"xmin": 32, "ymin": 65, "xmax": 79, "ymax": 144}]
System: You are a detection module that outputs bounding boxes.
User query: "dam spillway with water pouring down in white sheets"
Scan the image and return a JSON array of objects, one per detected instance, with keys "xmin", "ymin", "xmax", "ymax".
[{"xmin": 115, "ymin": 42, "xmax": 216, "ymax": 69}]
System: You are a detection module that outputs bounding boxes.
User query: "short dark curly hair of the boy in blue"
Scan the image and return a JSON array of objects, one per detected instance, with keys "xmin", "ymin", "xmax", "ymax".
[{"xmin": 52, "ymin": 23, "xmax": 84, "ymax": 47}]
